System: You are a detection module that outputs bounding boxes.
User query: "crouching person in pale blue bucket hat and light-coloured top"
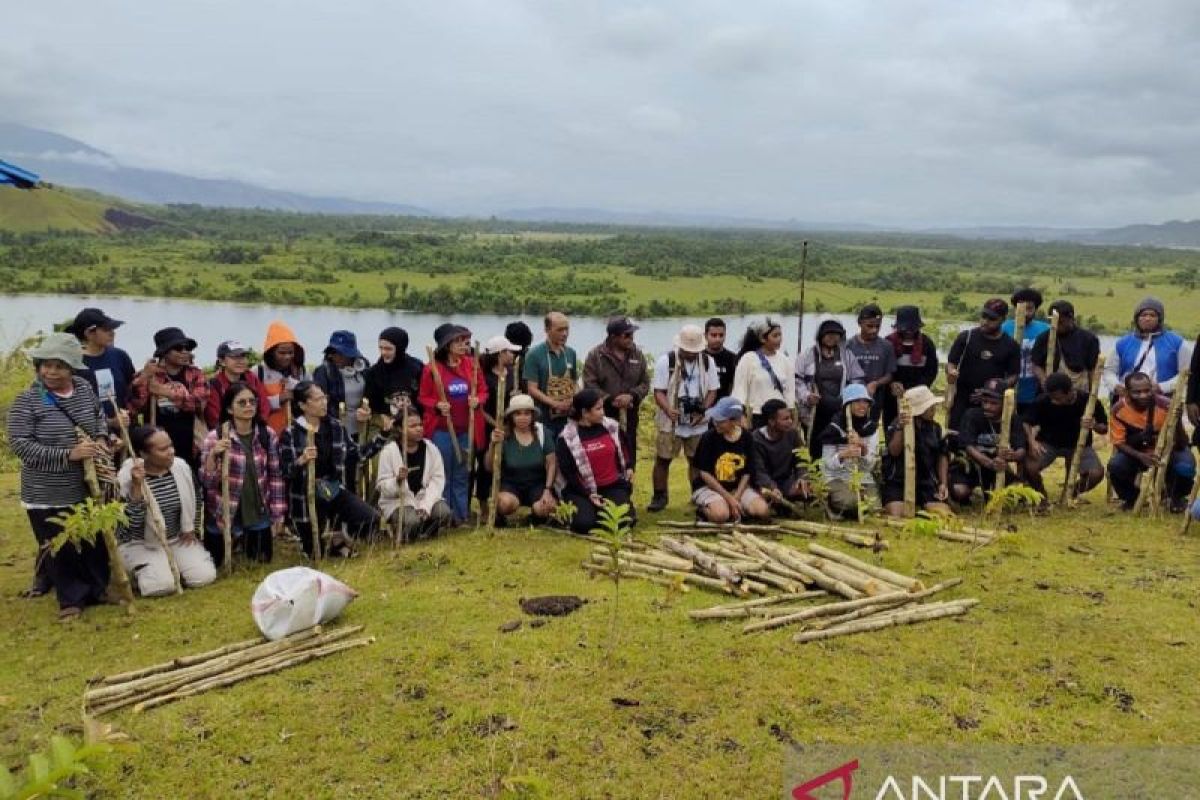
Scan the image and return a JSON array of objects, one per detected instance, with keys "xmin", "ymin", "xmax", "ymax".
[{"xmin": 816, "ymin": 384, "xmax": 880, "ymax": 516}]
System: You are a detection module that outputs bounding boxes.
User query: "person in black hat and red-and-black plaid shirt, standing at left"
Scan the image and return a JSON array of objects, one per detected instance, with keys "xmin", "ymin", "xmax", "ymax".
[{"xmin": 130, "ymin": 327, "xmax": 209, "ymax": 470}]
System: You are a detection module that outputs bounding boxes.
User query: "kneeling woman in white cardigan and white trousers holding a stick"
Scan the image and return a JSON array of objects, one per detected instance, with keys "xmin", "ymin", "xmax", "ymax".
[{"xmin": 116, "ymin": 424, "xmax": 216, "ymax": 597}]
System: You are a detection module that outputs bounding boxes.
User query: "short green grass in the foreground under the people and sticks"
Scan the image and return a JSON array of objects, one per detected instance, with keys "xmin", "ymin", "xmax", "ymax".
[{"xmin": 0, "ymin": 438, "xmax": 1200, "ymax": 798}]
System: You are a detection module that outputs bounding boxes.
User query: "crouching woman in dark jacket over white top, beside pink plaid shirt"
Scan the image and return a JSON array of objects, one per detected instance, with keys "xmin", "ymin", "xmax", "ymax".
[{"xmin": 280, "ymin": 380, "xmax": 391, "ymax": 558}]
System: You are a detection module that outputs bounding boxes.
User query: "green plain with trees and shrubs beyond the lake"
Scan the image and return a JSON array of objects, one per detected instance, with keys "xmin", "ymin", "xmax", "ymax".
[{"xmin": 0, "ymin": 205, "xmax": 1200, "ymax": 332}]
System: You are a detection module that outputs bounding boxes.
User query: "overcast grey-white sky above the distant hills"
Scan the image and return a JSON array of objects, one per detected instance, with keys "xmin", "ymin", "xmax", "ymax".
[{"xmin": 0, "ymin": 0, "xmax": 1200, "ymax": 225}]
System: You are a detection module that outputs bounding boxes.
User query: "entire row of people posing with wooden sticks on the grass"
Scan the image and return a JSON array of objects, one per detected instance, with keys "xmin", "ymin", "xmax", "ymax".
[{"xmin": 8, "ymin": 289, "xmax": 1200, "ymax": 619}]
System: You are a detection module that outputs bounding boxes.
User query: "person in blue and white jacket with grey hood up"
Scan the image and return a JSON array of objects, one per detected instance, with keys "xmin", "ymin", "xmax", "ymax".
[{"xmin": 1104, "ymin": 297, "xmax": 1192, "ymax": 403}]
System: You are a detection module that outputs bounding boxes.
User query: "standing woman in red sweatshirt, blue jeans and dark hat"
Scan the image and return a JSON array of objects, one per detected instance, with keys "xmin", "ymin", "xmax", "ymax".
[{"xmin": 418, "ymin": 323, "xmax": 488, "ymax": 525}]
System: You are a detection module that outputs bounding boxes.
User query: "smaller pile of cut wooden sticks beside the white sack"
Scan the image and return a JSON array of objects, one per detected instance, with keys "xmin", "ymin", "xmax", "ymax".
[{"xmin": 84, "ymin": 625, "xmax": 374, "ymax": 716}]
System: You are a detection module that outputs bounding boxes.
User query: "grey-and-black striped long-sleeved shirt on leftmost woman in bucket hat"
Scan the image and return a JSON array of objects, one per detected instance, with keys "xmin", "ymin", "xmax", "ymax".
[{"xmin": 8, "ymin": 377, "xmax": 108, "ymax": 509}]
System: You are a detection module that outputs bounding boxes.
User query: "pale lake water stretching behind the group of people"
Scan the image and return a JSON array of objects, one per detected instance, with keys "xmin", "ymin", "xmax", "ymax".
[{"xmin": 0, "ymin": 295, "xmax": 890, "ymax": 365}]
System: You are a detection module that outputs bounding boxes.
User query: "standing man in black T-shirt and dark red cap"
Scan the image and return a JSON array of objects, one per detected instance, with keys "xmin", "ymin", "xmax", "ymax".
[{"xmin": 946, "ymin": 297, "xmax": 1021, "ymax": 435}]
